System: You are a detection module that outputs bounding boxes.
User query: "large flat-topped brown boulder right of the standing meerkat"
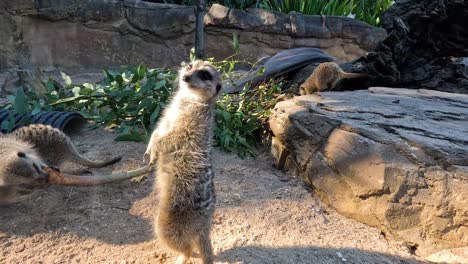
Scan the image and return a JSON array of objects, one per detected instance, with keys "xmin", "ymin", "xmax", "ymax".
[{"xmin": 270, "ymin": 88, "xmax": 468, "ymax": 256}]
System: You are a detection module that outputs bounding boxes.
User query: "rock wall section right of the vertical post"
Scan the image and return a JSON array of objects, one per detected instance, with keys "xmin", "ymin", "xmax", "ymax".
[{"xmin": 205, "ymin": 4, "xmax": 386, "ymax": 63}]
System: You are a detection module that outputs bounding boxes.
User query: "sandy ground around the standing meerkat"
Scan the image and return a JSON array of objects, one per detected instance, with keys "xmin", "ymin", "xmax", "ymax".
[{"xmin": 0, "ymin": 129, "xmax": 426, "ymax": 264}]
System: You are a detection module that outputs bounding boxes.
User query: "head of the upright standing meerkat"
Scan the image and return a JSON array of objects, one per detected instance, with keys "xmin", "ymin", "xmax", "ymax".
[{"xmin": 179, "ymin": 61, "xmax": 222, "ymax": 102}]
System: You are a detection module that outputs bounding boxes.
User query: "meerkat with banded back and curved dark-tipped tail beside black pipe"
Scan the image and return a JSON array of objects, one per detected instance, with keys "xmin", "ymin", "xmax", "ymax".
[{"xmin": 13, "ymin": 124, "xmax": 122, "ymax": 168}]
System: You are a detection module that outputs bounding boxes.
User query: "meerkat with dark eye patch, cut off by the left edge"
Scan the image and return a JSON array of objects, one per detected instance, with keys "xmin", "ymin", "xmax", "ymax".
[{"xmin": 0, "ymin": 136, "xmax": 48, "ymax": 205}]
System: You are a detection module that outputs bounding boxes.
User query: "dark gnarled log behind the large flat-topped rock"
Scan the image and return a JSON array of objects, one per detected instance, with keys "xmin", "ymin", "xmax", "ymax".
[{"xmin": 340, "ymin": 0, "xmax": 468, "ymax": 93}]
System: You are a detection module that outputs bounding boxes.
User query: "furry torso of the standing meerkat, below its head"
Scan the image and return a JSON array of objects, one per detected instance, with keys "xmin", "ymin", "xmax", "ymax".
[{"xmin": 156, "ymin": 98, "xmax": 215, "ymax": 254}]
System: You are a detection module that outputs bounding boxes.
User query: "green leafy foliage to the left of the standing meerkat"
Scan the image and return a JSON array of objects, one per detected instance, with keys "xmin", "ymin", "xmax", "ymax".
[{"xmin": 4, "ymin": 65, "xmax": 176, "ymax": 141}]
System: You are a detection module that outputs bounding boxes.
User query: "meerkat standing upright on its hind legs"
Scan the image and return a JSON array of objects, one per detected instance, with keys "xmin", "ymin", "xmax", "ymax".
[{"xmin": 145, "ymin": 61, "xmax": 222, "ymax": 264}]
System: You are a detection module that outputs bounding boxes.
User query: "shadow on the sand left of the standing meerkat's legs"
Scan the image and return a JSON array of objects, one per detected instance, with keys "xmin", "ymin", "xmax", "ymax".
[{"xmin": 0, "ymin": 174, "xmax": 155, "ymax": 245}]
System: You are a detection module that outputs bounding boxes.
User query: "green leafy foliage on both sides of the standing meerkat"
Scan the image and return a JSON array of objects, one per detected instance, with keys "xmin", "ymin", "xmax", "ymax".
[{"xmin": 2, "ymin": 61, "xmax": 283, "ymax": 157}]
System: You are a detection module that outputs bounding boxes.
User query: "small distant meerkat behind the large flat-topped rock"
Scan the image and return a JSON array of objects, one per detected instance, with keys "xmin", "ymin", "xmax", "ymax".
[{"xmin": 299, "ymin": 62, "xmax": 367, "ymax": 95}]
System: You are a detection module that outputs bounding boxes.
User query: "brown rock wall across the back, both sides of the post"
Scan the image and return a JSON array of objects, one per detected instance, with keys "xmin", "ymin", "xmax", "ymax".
[{"xmin": 0, "ymin": 0, "xmax": 386, "ymax": 70}]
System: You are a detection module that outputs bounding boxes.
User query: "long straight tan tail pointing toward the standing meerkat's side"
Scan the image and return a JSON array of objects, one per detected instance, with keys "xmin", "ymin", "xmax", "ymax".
[{"xmin": 44, "ymin": 165, "xmax": 154, "ymax": 186}]
